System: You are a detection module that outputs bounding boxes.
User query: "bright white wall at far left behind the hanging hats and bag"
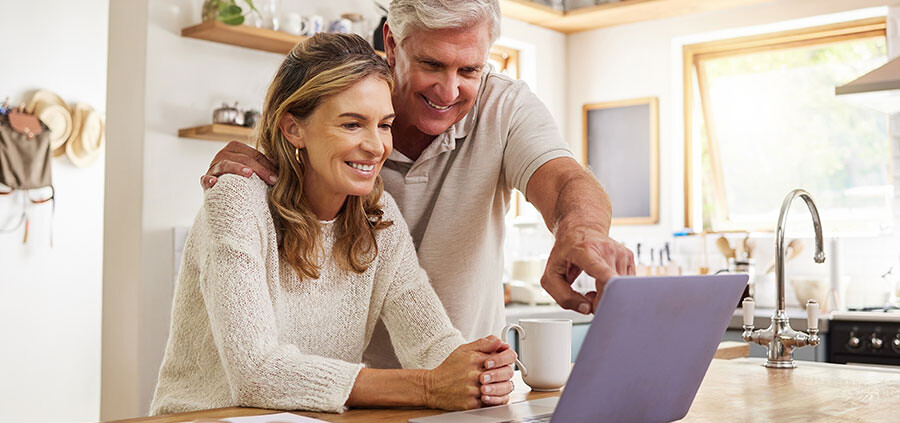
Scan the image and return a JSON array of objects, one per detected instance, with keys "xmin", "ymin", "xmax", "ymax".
[{"xmin": 0, "ymin": 0, "xmax": 109, "ymax": 422}]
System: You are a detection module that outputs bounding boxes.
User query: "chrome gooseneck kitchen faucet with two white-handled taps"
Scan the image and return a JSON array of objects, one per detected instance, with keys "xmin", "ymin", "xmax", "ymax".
[{"xmin": 741, "ymin": 189, "xmax": 825, "ymax": 369}]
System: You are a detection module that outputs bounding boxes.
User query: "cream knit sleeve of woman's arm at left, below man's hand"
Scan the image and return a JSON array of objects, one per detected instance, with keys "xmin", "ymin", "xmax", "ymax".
[{"xmin": 200, "ymin": 176, "xmax": 362, "ymax": 412}]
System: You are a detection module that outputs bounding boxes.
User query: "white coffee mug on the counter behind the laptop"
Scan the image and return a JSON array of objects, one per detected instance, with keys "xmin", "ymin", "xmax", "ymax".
[{"xmin": 502, "ymin": 319, "xmax": 572, "ymax": 391}]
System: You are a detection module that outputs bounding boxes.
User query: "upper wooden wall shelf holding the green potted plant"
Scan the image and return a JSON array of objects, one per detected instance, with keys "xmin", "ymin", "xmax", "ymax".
[{"xmin": 181, "ymin": 21, "xmax": 308, "ymax": 54}]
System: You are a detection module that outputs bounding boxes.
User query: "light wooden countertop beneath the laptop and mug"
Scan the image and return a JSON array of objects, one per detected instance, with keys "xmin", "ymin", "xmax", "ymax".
[{"xmin": 105, "ymin": 358, "xmax": 900, "ymax": 423}]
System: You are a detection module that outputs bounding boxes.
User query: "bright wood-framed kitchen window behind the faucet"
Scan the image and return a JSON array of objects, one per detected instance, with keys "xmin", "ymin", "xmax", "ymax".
[{"xmin": 684, "ymin": 18, "xmax": 894, "ymax": 232}]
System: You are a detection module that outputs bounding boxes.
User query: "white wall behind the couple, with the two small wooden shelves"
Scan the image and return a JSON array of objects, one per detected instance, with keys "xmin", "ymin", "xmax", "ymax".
[{"xmin": 101, "ymin": 0, "xmax": 565, "ymax": 419}]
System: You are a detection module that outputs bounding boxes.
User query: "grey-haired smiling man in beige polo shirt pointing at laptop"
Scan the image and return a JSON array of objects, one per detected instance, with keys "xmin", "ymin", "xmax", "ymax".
[{"xmin": 201, "ymin": 0, "xmax": 634, "ymax": 367}]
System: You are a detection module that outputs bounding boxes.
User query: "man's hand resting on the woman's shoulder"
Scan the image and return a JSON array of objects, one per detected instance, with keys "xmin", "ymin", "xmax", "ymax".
[{"xmin": 200, "ymin": 141, "xmax": 278, "ymax": 190}]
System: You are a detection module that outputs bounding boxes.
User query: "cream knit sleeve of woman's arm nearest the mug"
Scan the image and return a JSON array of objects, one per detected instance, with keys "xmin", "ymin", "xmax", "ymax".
[{"xmin": 381, "ymin": 196, "xmax": 465, "ymax": 369}]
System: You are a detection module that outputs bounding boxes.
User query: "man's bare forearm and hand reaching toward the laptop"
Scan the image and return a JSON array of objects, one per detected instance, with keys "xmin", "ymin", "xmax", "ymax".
[{"xmin": 525, "ymin": 157, "xmax": 634, "ymax": 314}]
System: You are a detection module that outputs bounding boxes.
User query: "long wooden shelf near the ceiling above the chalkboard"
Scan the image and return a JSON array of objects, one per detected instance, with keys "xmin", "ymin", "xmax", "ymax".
[{"xmin": 500, "ymin": 0, "xmax": 772, "ymax": 34}]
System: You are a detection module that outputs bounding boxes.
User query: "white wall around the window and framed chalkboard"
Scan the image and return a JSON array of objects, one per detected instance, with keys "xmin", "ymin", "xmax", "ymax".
[{"xmin": 565, "ymin": 0, "xmax": 900, "ymax": 305}]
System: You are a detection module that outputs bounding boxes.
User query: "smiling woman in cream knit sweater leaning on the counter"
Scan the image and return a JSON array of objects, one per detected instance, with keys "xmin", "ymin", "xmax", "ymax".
[{"xmin": 152, "ymin": 34, "xmax": 514, "ymax": 414}]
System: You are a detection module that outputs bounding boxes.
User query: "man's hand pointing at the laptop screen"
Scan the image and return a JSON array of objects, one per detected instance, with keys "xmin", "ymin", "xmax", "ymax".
[{"xmin": 541, "ymin": 224, "xmax": 634, "ymax": 314}]
